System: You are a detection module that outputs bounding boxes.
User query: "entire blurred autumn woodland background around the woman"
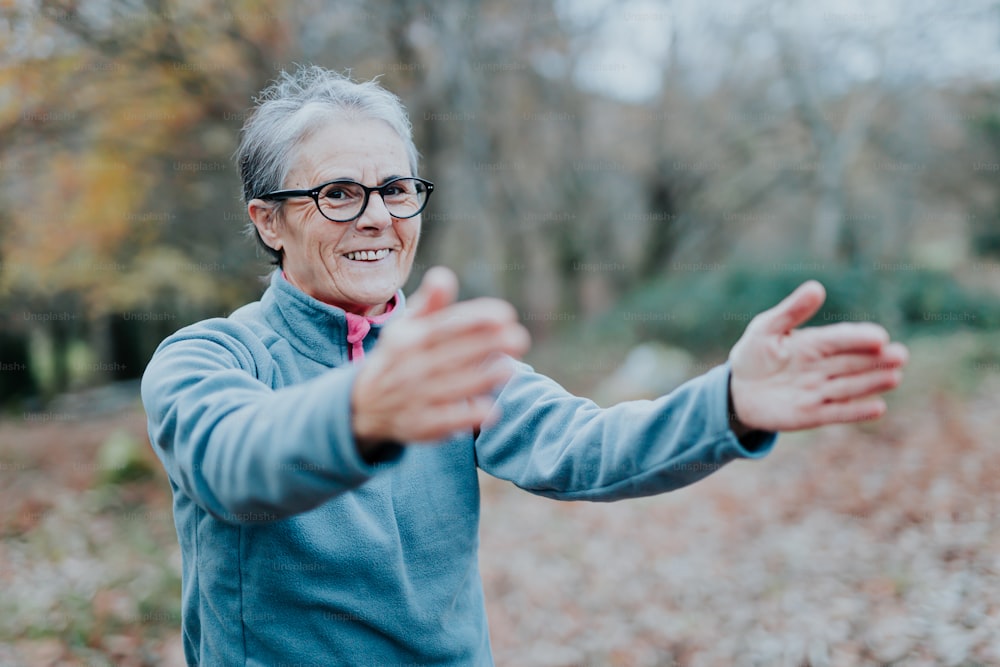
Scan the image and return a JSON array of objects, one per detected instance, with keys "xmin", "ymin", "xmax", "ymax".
[{"xmin": 0, "ymin": 0, "xmax": 1000, "ymax": 667}]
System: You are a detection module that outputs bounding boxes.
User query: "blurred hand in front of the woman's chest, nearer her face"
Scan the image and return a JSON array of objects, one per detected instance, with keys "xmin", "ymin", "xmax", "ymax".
[{"xmin": 351, "ymin": 267, "xmax": 530, "ymax": 452}]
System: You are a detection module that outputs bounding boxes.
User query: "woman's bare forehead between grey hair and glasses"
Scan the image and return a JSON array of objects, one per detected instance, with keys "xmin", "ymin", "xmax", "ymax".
[{"xmin": 290, "ymin": 116, "xmax": 410, "ymax": 179}]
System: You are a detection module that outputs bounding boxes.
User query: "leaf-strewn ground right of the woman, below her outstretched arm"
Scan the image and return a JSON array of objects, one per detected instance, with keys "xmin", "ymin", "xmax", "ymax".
[{"xmin": 482, "ymin": 383, "xmax": 1000, "ymax": 667}]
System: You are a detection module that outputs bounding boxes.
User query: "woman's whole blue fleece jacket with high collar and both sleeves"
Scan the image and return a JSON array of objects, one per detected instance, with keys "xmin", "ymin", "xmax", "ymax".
[{"xmin": 142, "ymin": 271, "xmax": 774, "ymax": 667}]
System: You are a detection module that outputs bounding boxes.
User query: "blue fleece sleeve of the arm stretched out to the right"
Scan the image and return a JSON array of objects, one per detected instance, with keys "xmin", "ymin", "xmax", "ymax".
[{"xmin": 476, "ymin": 364, "xmax": 777, "ymax": 501}]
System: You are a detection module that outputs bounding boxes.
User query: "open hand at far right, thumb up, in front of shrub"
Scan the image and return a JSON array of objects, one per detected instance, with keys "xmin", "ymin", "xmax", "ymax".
[{"xmin": 729, "ymin": 280, "xmax": 908, "ymax": 431}]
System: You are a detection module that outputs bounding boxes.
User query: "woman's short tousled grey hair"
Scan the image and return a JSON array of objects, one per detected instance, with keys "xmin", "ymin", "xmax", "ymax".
[{"xmin": 236, "ymin": 65, "xmax": 419, "ymax": 266}]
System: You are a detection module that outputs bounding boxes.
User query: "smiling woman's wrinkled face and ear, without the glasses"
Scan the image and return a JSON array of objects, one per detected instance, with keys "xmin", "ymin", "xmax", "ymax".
[{"xmin": 249, "ymin": 118, "xmax": 420, "ymax": 315}]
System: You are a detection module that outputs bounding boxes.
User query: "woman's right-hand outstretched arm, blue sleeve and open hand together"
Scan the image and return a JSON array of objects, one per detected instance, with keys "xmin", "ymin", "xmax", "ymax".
[{"xmin": 476, "ymin": 281, "xmax": 907, "ymax": 500}]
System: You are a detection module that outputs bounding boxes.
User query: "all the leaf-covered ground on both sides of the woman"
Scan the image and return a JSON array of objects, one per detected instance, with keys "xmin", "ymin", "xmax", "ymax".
[{"xmin": 0, "ymin": 368, "xmax": 1000, "ymax": 667}]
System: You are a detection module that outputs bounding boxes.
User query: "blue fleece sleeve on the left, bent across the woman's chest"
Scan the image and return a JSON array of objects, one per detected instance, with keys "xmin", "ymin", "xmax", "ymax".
[{"xmin": 142, "ymin": 320, "xmax": 401, "ymax": 523}]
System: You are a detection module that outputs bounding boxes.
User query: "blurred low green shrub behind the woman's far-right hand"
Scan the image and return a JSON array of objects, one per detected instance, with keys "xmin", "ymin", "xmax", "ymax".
[{"xmin": 598, "ymin": 263, "xmax": 1000, "ymax": 355}]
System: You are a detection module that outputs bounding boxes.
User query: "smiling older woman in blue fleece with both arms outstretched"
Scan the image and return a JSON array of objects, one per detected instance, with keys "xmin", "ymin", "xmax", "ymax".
[{"xmin": 142, "ymin": 67, "xmax": 906, "ymax": 665}]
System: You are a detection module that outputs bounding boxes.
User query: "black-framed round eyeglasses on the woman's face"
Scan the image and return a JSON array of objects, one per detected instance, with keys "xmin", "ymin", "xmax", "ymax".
[{"xmin": 259, "ymin": 176, "xmax": 434, "ymax": 222}]
